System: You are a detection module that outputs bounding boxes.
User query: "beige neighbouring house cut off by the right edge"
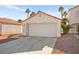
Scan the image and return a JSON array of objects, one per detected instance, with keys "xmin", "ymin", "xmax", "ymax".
[{"xmin": 67, "ymin": 6, "xmax": 79, "ymax": 33}]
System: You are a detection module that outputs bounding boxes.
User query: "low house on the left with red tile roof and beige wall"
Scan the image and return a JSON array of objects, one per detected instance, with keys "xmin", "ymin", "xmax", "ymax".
[{"xmin": 0, "ymin": 18, "xmax": 22, "ymax": 35}]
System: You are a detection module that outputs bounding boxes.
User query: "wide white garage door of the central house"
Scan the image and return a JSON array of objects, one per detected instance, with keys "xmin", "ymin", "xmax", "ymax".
[{"xmin": 29, "ymin": 23, "xmax": 57, "ymax": 37}]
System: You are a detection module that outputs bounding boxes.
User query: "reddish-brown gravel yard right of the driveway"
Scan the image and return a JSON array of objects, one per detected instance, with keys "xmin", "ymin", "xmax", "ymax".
[{"xmin": 52, "ymin": 34, "xmax": 79, "ymax": 54}]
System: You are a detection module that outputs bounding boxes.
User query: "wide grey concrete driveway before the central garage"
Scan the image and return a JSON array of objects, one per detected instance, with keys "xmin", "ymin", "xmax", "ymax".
[{"xmin": 0, "ymin": 35, "xmax": 57, "ymax": 54}]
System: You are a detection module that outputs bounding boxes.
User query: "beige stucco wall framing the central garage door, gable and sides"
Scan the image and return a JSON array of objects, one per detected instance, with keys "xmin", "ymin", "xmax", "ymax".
[{"xmin": 23, "ymin": 13, "xmax": 61, "ymax": 37}]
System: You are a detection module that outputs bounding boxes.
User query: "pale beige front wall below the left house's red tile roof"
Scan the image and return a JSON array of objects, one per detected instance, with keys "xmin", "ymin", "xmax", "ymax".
[{"xmin": 2, "ymin": 24, "xmax": 22, "ymax": 34}]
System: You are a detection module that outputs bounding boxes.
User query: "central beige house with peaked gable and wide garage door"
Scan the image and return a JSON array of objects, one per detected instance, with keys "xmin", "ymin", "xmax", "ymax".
[{"xmin": 23, "ymin": 11, "xmax": 61, "ymax": 37}]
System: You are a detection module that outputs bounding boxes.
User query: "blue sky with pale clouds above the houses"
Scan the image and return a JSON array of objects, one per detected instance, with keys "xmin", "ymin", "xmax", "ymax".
[{"xmin": 0, "ymin": 5, "xmax": 74, "ymax": 20}]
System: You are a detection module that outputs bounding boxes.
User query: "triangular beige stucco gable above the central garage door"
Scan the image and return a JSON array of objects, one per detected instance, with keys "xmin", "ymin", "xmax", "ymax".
[{"xmin": 26, "ymin": 13, "xmax": 60, "ymax": 23}]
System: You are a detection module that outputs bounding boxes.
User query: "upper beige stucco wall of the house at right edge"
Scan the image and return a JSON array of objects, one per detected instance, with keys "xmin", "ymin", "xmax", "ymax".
[{"xmin": 67, "ymin": 7, "xmax": 79, "ymax": 24}]
